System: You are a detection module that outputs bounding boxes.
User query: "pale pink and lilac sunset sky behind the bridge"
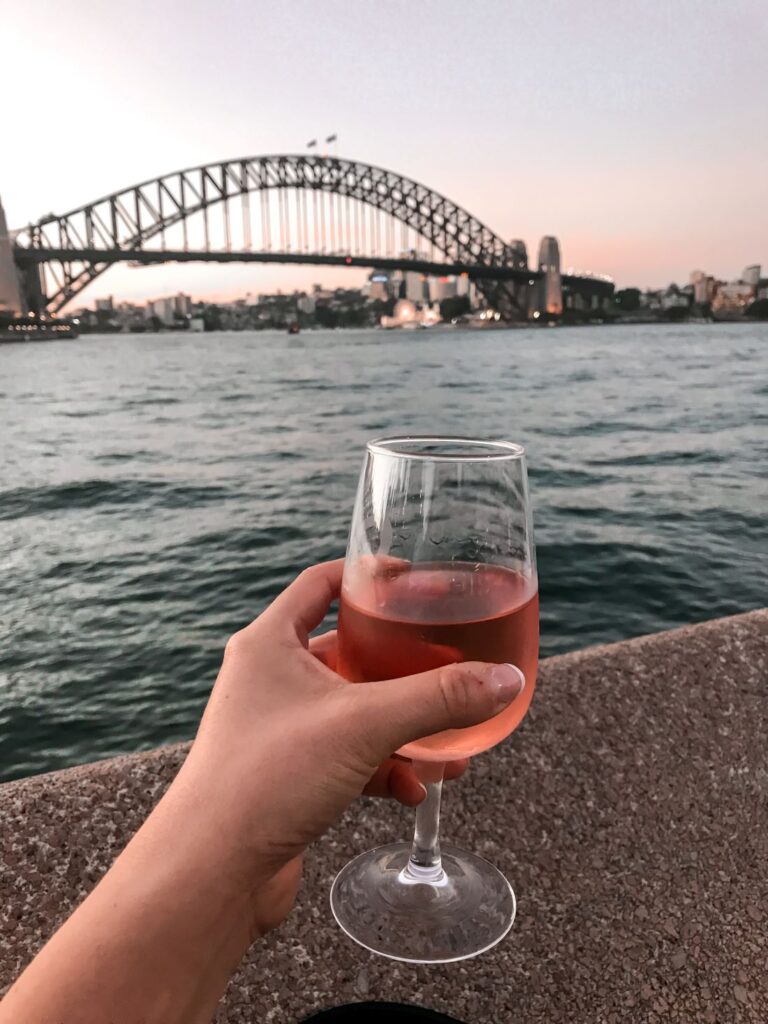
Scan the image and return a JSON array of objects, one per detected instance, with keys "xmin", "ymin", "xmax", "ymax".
[{"xmin": 0, "ymin": 0, "xmax": 768, "ymax": 302}]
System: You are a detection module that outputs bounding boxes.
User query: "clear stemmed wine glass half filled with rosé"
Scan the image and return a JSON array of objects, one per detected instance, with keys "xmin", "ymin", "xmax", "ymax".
[{"xmin": 331, "ymin": 437, "xmax": 539, "ymax": 964}]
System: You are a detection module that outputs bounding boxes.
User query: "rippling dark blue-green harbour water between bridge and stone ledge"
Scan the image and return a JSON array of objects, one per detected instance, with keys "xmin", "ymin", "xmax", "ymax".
[{"xmin": 0, "ymin": 325, "xmax": 768, "ymax": 778}]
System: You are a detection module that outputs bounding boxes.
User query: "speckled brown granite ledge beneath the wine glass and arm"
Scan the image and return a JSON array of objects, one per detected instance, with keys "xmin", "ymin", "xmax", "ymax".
[{"xmin": 0, "ymin": 610, "xmax": 768, "ymax": 1024}]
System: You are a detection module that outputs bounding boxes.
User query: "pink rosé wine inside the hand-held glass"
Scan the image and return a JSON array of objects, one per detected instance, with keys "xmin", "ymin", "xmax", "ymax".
[{"xmin": 339, "ymin": 559, "xmax": 539, "ymax": 761}]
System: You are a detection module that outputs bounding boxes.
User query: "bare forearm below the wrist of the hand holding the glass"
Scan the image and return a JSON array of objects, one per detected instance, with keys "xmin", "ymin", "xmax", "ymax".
[{"xmin": 0, "ymin": 773, "xmax": 263, "ymax": 1024}]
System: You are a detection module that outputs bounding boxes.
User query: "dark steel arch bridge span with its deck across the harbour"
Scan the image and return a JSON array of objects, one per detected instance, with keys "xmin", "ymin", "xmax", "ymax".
[{"xmin": 13, "ymin": 155, "xmax": 540, "ymax": 319}]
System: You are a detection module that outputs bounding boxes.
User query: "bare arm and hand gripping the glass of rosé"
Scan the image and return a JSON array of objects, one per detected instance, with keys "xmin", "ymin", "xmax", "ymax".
[{"xmin": 0, "ymin": 562, "xmax": 518, "ymax": 1024}]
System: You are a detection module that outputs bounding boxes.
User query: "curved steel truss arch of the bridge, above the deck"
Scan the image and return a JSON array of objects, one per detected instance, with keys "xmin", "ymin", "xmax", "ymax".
[{"xmin": 15, "ymin": 155, "xmax": 538, "ymax": 312}]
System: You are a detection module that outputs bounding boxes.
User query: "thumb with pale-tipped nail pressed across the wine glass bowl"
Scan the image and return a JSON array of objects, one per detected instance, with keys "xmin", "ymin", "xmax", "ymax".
[{"xmin": 354, "ymin": 662, "xmax": 525, "ymax": 758}]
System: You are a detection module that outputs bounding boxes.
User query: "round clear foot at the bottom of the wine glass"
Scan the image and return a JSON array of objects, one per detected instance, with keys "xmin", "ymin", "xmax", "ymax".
[{"xmin": 331, "ymin": 843, "xmax": 516, "ymax": 964}]
